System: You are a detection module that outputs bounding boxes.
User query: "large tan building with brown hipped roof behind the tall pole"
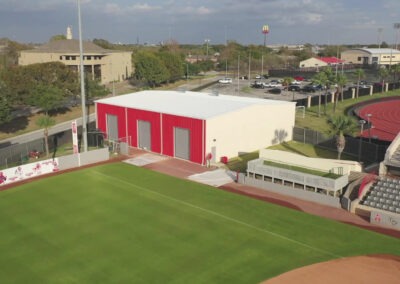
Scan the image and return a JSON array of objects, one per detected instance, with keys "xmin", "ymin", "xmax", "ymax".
[{"xmin": 18, "ymin": 26, "xmax": 132, "ymax": 84}]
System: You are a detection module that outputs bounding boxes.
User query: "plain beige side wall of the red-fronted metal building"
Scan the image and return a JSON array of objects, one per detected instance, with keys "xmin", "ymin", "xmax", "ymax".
[{"xmin": 206, "ymin": 102, "xmax": 296, "ymax": 161}]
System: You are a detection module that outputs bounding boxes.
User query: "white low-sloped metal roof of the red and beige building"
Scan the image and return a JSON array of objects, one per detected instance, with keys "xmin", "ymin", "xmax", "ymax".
[{"xmin": 96, "ymin": 91, "xmax": 295, "ymax": 119}]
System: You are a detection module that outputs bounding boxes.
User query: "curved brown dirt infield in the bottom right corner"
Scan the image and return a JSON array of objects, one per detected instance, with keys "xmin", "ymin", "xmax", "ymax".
[{"xmin": 262, "ymin": 255, "xmax": 400, "ymax": 284}]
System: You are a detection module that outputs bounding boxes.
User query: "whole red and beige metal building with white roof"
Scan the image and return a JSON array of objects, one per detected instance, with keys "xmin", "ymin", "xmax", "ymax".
[{"xmin": 95, "ymin": 91, "xmax": 296, "ymax": 165}]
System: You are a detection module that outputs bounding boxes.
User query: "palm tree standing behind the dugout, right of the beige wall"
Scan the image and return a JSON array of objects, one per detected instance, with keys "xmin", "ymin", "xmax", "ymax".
[{"xmin": 327, "ymin": 115, "xmax": 355, "ymax": 160}]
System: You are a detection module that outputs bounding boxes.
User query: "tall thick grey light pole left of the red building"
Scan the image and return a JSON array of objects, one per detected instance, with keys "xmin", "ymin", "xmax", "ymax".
[{"xmin": 78, "ymin": 0, "xmax": 88, "ymax": 152}]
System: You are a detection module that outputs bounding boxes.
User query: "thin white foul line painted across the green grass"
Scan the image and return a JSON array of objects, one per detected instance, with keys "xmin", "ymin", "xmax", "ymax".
[{"xmin": 93, "ymin": 171, "xmax": 343, "ymax": 258}]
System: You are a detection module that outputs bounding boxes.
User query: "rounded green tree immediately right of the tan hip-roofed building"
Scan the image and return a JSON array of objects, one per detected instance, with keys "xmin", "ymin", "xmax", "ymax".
[{"xmin": 135, "ymin": 51, "xmax": 170, "ymax": 88}]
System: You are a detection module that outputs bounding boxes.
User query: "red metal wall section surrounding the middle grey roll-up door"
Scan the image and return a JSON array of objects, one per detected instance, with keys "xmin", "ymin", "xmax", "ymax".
[{"xmin": 128, "ymin": 109, "xmax": 161, "ymax": 153}]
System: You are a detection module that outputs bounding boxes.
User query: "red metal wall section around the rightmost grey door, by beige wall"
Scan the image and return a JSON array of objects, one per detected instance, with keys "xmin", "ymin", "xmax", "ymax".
[{"xmin": 162, "ymin": 114, "xmax": 205, "ymax": 164}]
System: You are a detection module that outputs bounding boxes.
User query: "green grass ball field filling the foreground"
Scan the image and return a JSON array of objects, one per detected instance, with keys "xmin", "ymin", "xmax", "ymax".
[{"xmin": 0, "ymin": 163, "xmax": 400, "ymax": 283}]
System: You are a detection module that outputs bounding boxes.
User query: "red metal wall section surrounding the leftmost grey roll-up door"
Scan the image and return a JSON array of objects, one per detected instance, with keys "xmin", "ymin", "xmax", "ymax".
[{"xmin": 96, "ymin": 103, "xmax": 127, "ymax": 138}]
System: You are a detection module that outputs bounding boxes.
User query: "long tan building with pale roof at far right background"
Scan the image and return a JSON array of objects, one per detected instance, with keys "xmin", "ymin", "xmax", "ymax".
[{"xmin": 341, "ymin": 48, "xmax": 400, "ymax": 66}]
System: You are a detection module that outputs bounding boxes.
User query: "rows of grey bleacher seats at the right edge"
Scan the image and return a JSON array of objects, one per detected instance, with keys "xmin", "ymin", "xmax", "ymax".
[{"xmin": 360, "ymin": 177, "xmax": 400, "ymax": 214}]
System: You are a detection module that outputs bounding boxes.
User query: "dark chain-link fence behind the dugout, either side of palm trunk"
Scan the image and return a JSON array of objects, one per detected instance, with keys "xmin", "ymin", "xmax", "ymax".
[{"xmin": 293, "ymin": 127, "xmax": 389, "ymax": 165}]
